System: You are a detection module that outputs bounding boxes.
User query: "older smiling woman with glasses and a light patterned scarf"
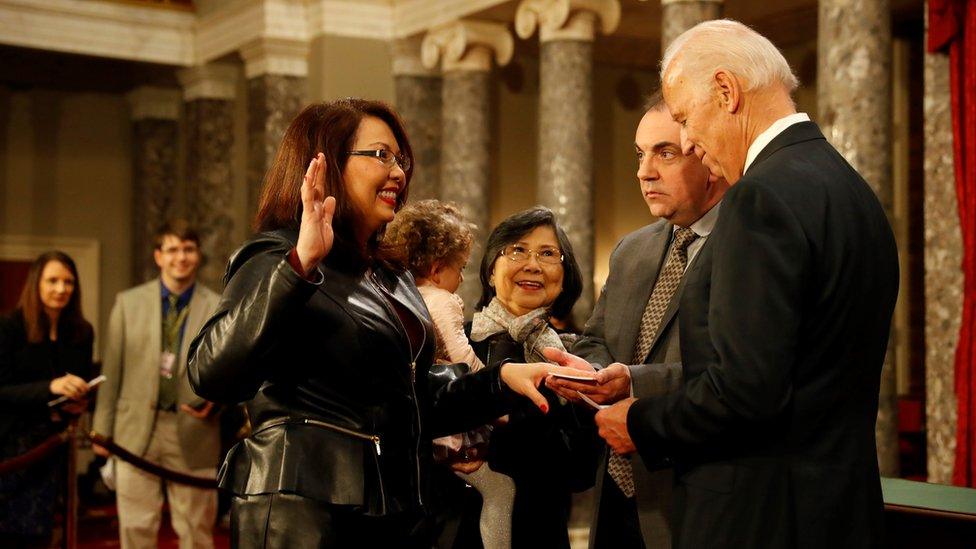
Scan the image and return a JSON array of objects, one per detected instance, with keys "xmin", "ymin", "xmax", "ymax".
[{"xmin": 436, "ymin": 207, "xmax": 599, "ymax": 548}]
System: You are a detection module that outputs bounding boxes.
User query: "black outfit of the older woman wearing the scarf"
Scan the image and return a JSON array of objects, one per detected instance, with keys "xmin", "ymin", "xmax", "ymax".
[{"xmin": 438, "ymin": 323, "xmax": 600, "ymax": 549}]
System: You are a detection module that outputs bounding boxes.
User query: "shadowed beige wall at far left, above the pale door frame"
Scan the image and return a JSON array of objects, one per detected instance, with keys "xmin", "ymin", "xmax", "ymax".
[{"xmin": 0, "ymin": 89, "xmax": 131, "ymax": 352}]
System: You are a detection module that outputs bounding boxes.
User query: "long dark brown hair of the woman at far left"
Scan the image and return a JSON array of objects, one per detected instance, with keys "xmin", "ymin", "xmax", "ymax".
[{"xmin": 17, "ymin": 250, "xmax": 92, "ymax": 343}]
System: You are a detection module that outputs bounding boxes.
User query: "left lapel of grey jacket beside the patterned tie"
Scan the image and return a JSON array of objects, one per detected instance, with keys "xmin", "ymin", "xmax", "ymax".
[{"xmin": 614, "ymin": 223, "xmax": 674, "ymax": 364}]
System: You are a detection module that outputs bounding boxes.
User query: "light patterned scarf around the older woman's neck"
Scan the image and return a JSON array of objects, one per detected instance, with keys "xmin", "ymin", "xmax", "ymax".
[{"xmin": 471, "ymin": 297, "xmax": 571, "ymax": 362}]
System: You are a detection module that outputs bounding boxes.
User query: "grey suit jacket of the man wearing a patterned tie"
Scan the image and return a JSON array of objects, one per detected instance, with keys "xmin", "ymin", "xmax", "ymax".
[{"xmin": 572, "ymin": 220, "xmax": 681, "ymax": 549}]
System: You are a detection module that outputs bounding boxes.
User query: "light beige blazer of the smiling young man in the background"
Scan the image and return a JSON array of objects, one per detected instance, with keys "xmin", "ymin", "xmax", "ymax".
[{"xmin": 92, "ymin": 278, "xmax": 220, "ymax": 469}]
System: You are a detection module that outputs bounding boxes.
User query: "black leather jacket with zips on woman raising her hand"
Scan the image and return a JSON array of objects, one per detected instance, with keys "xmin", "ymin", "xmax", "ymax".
[{"xmin": 188, "ymin": 230, "xmax": 511, "ymax": 515}]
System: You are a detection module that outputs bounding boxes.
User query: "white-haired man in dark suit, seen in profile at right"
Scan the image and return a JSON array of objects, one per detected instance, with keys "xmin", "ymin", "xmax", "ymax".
[{"xmin": 576, "ymin": 21, "xmax": 898, "ymax": 548}]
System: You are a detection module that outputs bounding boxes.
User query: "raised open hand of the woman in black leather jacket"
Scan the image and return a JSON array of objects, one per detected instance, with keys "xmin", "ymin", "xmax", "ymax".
[{"xmin": 295, "ymin": 153, "xmax": 335, "ymax": 273}]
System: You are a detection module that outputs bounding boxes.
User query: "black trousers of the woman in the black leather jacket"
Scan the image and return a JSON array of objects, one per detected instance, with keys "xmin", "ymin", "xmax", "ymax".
[{"xmin": 230, "ymin": 494, "xmax": 430, "ymax": 549}]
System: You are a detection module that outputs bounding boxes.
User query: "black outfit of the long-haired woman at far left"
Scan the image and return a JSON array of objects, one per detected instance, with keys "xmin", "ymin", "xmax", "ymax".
[{"xmin": 0, "ymin": 311, "xmax": 93, "ymax": 538}]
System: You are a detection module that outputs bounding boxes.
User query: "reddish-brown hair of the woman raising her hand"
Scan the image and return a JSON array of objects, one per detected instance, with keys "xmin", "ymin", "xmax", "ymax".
[{"xmin": 254, "ymin": 98, "xmax": 413, "ymax": 266}]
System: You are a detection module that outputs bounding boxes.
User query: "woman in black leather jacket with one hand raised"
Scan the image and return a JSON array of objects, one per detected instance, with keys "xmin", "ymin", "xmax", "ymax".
[{"xmin": 189, "ymin": 99, "xmax": 554, "ymax": 548}]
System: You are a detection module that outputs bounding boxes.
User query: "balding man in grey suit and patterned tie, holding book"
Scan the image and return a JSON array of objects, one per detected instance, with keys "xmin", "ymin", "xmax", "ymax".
[{"xmin": 549, "ymin": 94, "xmax": 728, "ymax": 549}]
